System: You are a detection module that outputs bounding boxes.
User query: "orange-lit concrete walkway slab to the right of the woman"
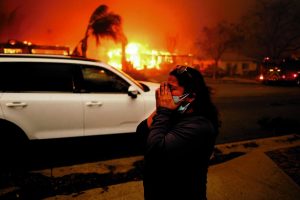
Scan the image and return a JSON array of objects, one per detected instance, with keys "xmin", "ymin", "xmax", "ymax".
[{"xmin": 208, "ymin": 148, "xmax": 300, "ymax": 200}]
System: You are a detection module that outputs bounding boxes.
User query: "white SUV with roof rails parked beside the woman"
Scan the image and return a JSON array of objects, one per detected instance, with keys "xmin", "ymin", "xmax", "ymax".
[{"xmin": 0, "ymin": 54, "xmax": 158, "ymax": 145}]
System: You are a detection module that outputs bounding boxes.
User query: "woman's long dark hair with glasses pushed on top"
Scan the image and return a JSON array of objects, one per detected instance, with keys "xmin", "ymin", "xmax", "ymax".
[{"xmin": 169, "ymin": 65, "xmax": 221, "ymax": 132}]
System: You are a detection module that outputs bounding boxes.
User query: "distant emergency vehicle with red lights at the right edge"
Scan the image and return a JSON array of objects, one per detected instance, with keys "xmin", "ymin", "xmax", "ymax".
[{"xmin": 259, "ymin": 58, "xmax": 300, "ymax": 86}]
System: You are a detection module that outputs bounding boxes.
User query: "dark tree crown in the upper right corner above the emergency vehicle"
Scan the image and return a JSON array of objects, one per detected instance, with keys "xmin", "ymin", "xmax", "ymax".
[{"xmin": 241, "ymin": 0, "xmax": 300, "ymax": 61}]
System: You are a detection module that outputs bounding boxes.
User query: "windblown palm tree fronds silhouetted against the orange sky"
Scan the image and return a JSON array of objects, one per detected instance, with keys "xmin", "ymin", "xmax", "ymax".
[{"xmin": 72, "ymin": 5, "xmax": 127, "ymax": 59}]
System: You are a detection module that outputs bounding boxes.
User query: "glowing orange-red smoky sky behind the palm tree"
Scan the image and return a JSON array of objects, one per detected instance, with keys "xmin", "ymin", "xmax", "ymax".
[{"xmin": 0, "ymin": 0, "xmax": 251, "ymax": 56}]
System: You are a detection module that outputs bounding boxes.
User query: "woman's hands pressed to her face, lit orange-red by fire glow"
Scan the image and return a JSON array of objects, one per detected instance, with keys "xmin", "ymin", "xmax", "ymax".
[{"xmin": 155, "ymin": 82, "xmax": 178, "ymax": 110}]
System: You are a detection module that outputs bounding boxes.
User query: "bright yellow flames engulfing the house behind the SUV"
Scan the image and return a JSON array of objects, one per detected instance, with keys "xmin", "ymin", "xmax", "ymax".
[{"xmin": 107, "ymin": 42, "xmax": 173, "ymax": 70}]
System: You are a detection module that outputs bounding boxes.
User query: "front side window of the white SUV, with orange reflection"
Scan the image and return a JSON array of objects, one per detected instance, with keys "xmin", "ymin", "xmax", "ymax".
[{"xmin": 82, "ymin": 67, "xmax": 129, "ymax": 93}]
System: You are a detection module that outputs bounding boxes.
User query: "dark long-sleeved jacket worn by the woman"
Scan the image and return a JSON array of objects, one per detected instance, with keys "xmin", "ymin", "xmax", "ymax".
[{"xmin": 137, "ymin": 108, "xmax": 217, "ymax": 200}]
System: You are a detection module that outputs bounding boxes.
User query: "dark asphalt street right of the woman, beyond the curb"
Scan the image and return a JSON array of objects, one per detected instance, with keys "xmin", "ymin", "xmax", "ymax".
[{"xmin": 209, "ymin": 83, "xmax": 300, "ymax": 143}]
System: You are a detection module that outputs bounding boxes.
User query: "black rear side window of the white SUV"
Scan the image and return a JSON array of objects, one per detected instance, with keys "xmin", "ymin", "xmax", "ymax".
[{"xmin": 0, "ymin": 62, "xmax": 73, "ymax": 92}]
